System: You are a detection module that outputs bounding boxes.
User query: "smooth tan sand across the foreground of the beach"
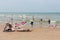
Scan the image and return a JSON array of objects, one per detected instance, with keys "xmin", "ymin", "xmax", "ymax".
[{"xmin": 0, "ymin": 27, "xmax": 60, "ymax": 40}]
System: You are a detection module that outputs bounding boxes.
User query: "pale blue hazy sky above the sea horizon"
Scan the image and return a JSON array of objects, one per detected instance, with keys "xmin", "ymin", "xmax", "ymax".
[{"xmin": 0, "ymin": 0, "xmax": 60, "ymax": 12}]
